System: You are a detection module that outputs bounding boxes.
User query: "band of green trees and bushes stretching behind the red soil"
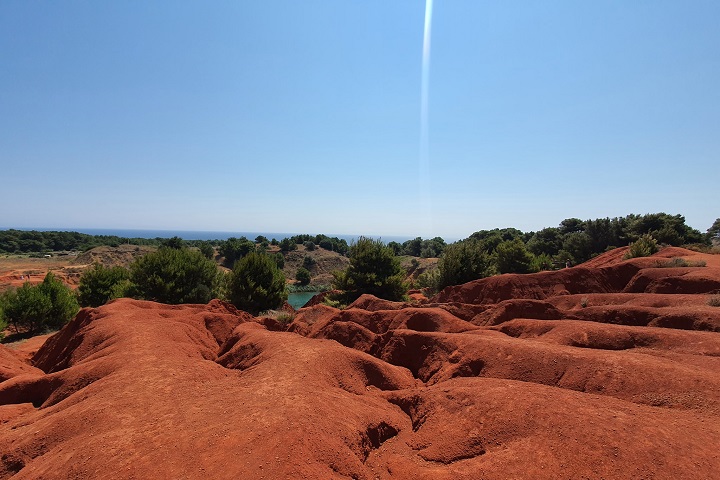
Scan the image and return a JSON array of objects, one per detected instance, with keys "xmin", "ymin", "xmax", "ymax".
[{"xmin": 0, "ymin": 213, "xmax": 720, "ymax": 331}]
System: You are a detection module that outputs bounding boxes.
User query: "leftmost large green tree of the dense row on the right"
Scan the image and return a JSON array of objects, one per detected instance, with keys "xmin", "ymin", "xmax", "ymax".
[{"xmin": 437, "ymin": 238, "xmax": 493, "ymax": 290}]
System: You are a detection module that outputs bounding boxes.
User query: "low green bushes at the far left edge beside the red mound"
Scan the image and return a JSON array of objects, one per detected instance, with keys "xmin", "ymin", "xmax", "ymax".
[{"xmin": 0, "ymin": 272, "xmax": 80, "ymax": 333}]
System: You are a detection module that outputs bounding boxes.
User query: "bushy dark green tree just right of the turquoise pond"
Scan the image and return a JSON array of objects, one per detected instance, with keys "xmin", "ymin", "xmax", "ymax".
[{"xmin": 333, "ymin": 237, "xmax": 407, "ymax": 303}]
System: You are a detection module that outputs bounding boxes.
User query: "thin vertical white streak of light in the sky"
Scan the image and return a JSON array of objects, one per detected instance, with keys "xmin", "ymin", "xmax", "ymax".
[{"xmin": 420, "ymin": 0, "xmax": 433, "ymax": 235}]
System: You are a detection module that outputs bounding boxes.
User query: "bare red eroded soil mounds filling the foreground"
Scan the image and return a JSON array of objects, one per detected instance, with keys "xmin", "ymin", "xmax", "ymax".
[{"xmin": 0, "ymin": 248, "xmax": 720, "ymax": 480}]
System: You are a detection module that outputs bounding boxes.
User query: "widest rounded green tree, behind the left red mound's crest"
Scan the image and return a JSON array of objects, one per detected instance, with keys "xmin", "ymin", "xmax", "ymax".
[{"xmin": 130, "ymin": 247, "xmax": 218, "ymax": 304}]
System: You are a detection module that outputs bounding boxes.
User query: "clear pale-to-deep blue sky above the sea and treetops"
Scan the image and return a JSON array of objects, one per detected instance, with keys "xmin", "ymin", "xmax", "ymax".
[{"xmin": 0, "ymin": 0, "xmax": 720, "ymax": 238}]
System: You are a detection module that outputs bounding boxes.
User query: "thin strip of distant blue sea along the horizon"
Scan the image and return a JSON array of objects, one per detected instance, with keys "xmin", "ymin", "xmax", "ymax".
[{"xmin": 3, "ymin": 227, "xmax": 415, "ymax": 243}]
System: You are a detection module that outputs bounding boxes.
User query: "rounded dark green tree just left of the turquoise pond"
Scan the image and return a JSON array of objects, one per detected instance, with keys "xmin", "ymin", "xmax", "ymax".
[{"xmin": 228, "ymin": 252, "xmax": 287, "ymax": 315}]
